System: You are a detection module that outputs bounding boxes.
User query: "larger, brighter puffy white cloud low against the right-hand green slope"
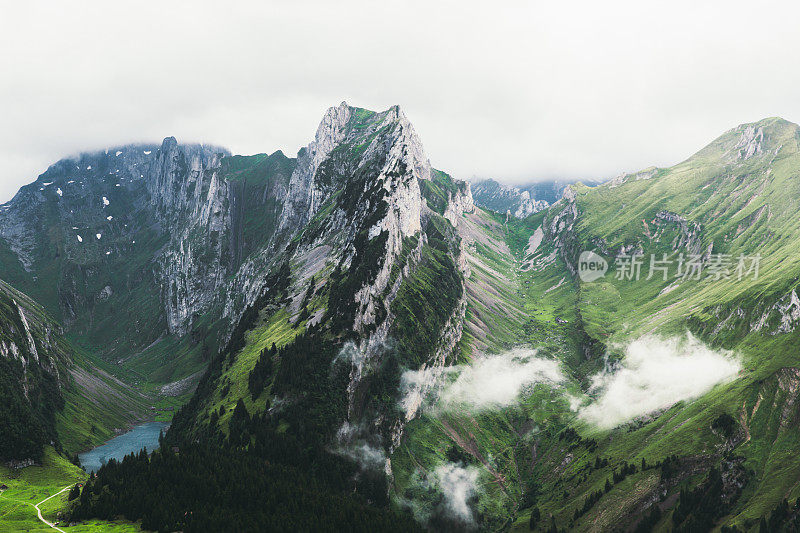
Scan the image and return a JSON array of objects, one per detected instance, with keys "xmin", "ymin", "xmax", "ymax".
[{"xmin": 579, "ymin": 334, "xmax": 741, "ymax": 429}]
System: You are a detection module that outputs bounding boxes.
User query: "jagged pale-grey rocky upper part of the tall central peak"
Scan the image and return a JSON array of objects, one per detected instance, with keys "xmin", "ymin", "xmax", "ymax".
[{"xmin": 219, "ymin": 103, "xmax": 440, "ymax": 344}]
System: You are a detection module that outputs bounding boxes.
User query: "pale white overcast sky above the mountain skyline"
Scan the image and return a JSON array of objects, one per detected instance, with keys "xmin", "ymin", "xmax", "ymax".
[{"xmin": 0, "ymin": 0, "xmax": 800, "ymax": 202}]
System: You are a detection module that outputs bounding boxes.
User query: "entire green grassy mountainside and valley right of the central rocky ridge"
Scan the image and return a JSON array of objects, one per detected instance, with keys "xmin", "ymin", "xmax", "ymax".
[{"xmin": 392, "ymin": 119, "xmax": 800, "ymax": 531}]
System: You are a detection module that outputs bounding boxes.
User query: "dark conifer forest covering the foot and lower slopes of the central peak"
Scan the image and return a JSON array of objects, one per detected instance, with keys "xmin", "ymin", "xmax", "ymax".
[{"xmin": 71, "ymin": 318, "xmax": 418, "ymax": 531}]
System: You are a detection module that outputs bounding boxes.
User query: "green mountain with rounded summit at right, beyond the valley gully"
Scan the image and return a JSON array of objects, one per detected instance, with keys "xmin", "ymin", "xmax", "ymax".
[{"xmin": 490, "ymin": 115, "xmax": 800, "ymax": 530}]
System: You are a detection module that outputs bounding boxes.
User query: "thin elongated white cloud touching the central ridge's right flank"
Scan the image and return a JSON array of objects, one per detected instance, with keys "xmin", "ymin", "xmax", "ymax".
[{"xmin": 402, "ymin": 349, "xmax": 564, "ymax": 418}]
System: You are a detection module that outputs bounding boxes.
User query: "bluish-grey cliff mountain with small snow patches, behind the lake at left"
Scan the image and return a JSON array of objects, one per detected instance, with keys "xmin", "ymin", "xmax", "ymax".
[{"xmin": 0, "ymin": 137, "xmax": 294, "ymax": 366}]
